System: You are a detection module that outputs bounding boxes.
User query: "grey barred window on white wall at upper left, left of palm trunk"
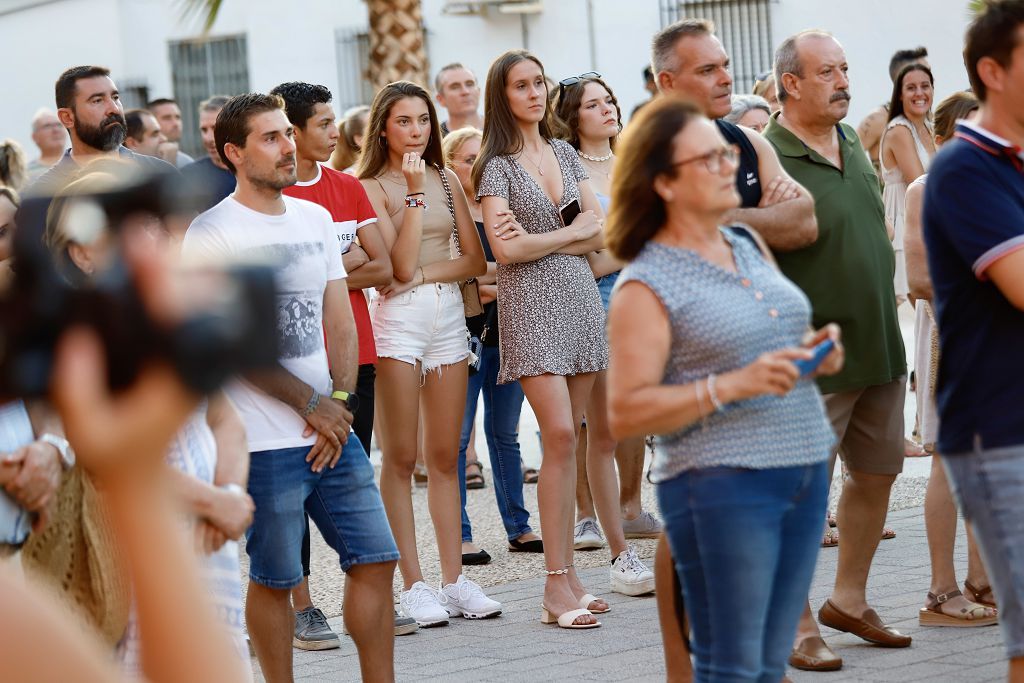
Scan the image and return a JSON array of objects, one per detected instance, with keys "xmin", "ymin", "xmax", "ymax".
[{"xmin": 168, "ymin": 36, "xmax": 249, "ymax": 159}]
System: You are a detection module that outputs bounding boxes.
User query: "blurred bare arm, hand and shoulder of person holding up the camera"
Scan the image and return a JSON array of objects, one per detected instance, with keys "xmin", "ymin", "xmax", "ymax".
[{"xmin": 0, "ymin": 228, "xmax": 248, "ymax": 683}]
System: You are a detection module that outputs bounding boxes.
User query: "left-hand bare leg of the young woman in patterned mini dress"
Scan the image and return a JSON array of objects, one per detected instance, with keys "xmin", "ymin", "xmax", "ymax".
[{"xmin": 520, "ymin": 374, "xmax": 597, "ymax": 625}]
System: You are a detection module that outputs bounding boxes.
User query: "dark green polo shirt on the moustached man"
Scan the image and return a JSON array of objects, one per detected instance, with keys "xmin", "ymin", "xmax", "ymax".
[{"xmin": 764, "ymin": 115, "xmax": 906, "ymax": 393}]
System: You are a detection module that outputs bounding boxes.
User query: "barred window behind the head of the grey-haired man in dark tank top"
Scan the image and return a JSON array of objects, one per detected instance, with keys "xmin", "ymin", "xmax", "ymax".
[{"xmin": 660, "ymin": 0, "xmax": 775, "ymax": 92}]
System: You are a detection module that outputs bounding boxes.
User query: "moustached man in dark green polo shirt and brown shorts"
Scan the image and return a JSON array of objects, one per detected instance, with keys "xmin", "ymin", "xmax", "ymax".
[{"xmin": 764, "ymin": 31, "xmax": 910, "ymax": 670}]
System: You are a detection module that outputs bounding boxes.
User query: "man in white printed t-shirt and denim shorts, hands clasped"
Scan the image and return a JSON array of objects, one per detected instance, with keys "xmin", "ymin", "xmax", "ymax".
[{"xmin": 184, "ymin": 93, "xmax": 398, "ymax": 681}]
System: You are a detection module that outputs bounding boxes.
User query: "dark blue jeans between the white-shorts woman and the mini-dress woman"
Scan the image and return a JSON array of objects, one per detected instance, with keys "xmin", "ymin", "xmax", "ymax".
[{"xmin": 459, "ymin": 346, "xmax": 534, "ymax": 542}]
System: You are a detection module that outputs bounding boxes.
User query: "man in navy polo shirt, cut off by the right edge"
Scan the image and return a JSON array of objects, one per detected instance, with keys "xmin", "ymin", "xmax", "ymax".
[{"xmin": 924, "ymin": 0, "xmax": 1024, "ymax": 681}]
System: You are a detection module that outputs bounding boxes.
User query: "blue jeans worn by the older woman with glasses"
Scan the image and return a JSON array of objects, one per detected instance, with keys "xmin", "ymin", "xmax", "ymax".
[{"xmin": 657, "ymin": 463, "xmax": 828, "ymax": 683}]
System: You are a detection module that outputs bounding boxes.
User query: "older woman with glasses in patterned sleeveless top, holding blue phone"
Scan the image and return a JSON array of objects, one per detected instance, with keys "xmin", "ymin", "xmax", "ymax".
[{"xmin": 605, "ymin": 97, "xmax": 843, "ymax": 681}]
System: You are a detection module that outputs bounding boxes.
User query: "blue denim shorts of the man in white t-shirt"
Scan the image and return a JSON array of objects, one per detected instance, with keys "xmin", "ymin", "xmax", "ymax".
[{"xmin": 246, "ymin": 433, "xmax": 398, "ymax": 589}]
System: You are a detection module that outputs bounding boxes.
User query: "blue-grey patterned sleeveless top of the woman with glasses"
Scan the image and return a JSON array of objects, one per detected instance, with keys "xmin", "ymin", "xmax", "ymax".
[{"xmin": 618, "ymin": 226, "xmax": 836, "ymax": 482}]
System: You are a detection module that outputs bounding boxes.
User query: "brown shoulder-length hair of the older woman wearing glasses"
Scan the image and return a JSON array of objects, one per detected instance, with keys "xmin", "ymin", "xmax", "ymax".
[{"xmin": 604, "ymin": 97, "xmax": 701, "ymax": 261}]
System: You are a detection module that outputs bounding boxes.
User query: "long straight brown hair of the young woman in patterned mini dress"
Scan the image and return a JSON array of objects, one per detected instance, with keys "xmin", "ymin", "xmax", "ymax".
[{"xmin": 473, "ymin": 50, "xmax": 555, "ymax": 187}]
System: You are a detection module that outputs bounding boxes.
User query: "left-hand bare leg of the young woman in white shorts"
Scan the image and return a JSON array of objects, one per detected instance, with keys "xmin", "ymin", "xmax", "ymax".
[{"xmin": 374, "ymin": 358, "xmax": 423, "ymax": 591}]
